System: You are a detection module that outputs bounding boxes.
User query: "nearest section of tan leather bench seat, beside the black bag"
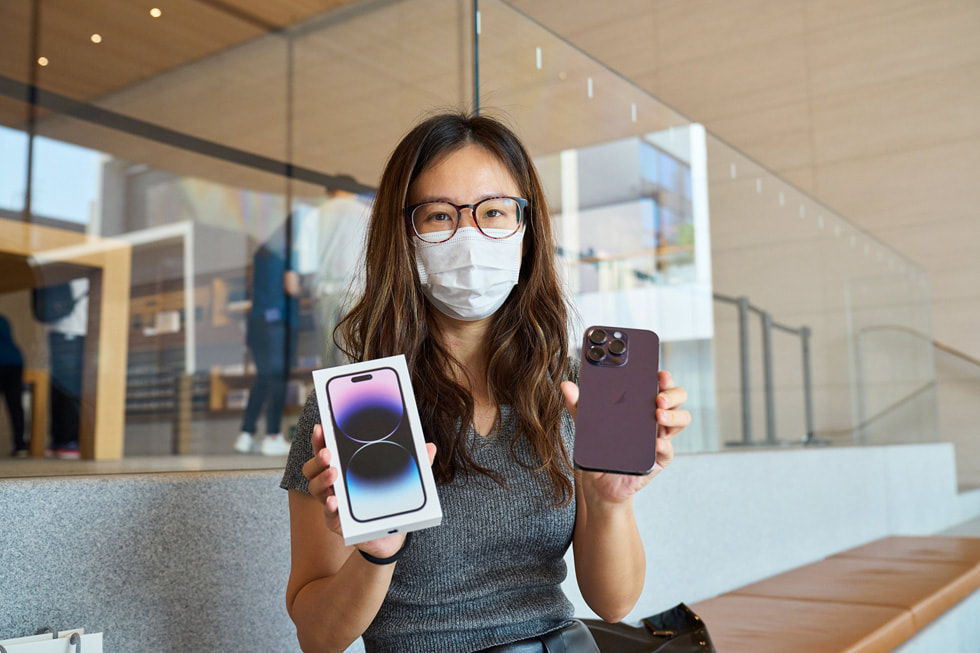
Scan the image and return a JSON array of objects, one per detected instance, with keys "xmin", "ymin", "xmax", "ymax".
[{"xmin": 691, "ymin": 594, "xmax": 916, "ymax": 653}]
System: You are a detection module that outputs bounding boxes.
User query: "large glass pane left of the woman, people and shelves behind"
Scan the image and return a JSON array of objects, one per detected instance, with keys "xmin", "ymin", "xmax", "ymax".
[{"xmin": 0, "ymin": 0, "xmax": 473, "ymax": 476}]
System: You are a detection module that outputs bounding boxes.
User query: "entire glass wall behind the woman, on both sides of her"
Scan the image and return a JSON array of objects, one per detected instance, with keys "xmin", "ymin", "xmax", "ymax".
[{"xmin": 0, "ymin": 0, "xmax": 948, "ymax": 474}]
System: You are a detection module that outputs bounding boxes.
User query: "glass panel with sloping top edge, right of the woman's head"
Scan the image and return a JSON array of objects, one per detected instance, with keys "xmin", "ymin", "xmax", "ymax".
[{"xmin": 479, "ymin": 0, "xmax": 937, "ymax": 451}]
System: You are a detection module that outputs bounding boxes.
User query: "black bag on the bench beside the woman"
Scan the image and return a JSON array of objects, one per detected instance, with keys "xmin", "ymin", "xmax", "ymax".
[{"xmin": 582, "ymin": 603, "xmax": 717, "ymax": 653}]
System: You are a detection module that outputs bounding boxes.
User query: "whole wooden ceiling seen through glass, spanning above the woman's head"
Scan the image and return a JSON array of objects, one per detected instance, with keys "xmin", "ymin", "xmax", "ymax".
[{"xmin": 0, "ymin": 0, "xmax": 686, "ymax": 195}]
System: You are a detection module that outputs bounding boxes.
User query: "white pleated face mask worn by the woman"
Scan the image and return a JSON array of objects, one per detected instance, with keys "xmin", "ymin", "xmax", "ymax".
[{"xmin": 415, "ymin": 227, "xmax": 524, "ymax": 322}]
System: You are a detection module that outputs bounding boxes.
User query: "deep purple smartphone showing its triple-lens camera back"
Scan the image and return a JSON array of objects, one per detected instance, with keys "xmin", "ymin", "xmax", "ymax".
[{"xmin": 573, "ymin": 326, "xmax": 660, "ymax": 474}]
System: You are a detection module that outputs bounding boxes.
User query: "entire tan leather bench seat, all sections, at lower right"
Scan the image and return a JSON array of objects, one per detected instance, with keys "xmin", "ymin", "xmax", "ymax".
[{"xmin": 691, "ymin": 536, "xmax": 980, "ymax": 653}]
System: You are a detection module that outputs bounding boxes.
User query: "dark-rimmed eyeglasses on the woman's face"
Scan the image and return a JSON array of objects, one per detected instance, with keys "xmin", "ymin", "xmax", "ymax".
[{"xmin": 405, "ymin": 197, "xmax": 527, "ymax": 243}]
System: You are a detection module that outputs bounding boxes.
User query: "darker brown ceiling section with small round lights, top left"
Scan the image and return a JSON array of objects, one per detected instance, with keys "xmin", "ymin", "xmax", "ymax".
[{"xmin": 0, "ymin": 0, "xmax": 360, "ymax": 109}]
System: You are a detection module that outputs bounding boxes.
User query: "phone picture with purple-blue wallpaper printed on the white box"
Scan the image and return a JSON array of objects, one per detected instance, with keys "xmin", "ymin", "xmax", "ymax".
[{"xmin": 327, "ymin": 367, "xmax": 426, "ymax": 522}]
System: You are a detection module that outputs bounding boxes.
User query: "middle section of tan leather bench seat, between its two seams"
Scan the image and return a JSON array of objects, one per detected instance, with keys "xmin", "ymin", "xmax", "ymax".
[{"xmin": 731, "ymin": 556, "xmax": 980, "ymax": 630}]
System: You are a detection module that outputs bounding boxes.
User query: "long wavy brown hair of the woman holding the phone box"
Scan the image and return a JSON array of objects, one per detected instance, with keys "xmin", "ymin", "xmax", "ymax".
[{"xmin": 335, "ymin": 113, "xmax": 573, "ymax": 504}]
